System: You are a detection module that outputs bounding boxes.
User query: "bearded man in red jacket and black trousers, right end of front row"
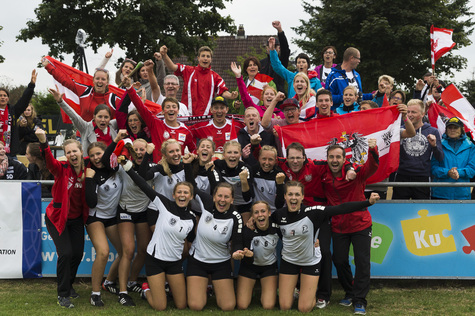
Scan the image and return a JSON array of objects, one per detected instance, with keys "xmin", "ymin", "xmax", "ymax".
[{"xmin": 322, "ymin": 139, "xmax": 379, "ymax": 315}]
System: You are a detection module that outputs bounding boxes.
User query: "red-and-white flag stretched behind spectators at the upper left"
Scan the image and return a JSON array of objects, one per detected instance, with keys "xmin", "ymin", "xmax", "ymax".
[{"xmin": 45, "ymin": 56, "xmax": 162, "ymax": 123}]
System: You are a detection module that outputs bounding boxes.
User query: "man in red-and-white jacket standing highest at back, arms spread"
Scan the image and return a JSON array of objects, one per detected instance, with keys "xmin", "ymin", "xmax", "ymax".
[{"xmin": 160, "ymin": 46, "xmax": 238, "ymax": 116}]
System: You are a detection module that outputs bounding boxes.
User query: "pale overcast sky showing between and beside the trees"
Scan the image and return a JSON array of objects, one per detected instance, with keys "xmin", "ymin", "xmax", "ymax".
[{"xmin": 0, "ymin": 0, "xmax": 475, "ymax": 92}]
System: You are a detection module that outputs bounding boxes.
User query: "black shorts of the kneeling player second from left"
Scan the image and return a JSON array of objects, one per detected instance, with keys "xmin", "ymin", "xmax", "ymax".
[{"xmin": 186, "ymin": 257, "xmax": 233, "ymax": 280}]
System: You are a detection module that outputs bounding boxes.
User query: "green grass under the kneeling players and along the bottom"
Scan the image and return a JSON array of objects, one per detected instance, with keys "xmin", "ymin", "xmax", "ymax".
[{"xmin": 0, "ymin": 278, "xmax": 475, "ymax": 315}]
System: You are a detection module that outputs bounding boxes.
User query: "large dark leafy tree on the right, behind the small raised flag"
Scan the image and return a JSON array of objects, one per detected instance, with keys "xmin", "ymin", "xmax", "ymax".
[{"xmin": 294, "ymin": 0, "xmax": 475, "ymax": 92}]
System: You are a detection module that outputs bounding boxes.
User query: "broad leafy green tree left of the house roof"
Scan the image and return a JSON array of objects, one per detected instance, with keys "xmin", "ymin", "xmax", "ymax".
[{"xmin": 17, "ymin": 0, "xmax": 235, "ymax": 60}]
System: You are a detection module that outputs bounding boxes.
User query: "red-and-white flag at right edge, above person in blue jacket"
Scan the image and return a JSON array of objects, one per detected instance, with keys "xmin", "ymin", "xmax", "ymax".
[{"xmin": 427, "ymin": 84, "xmax": 475, "ymax": 139}]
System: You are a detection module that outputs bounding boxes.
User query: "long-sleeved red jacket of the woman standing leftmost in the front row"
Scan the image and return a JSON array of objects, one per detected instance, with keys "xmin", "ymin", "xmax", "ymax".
[{"xmin": 41, "ymin": 144, "xmax": 89, "ymax": 235}]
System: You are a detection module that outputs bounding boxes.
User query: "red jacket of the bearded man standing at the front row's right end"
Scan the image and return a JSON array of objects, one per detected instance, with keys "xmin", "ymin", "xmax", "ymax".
[{"xmin": 322, "ymin": 148, "xmax": 379, "ymax": 234}]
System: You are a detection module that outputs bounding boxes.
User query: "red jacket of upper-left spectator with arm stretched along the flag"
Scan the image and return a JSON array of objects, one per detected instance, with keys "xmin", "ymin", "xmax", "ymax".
[{"xmin": 46, "ymin": 63, "xmax": 120, "ymax": 121}]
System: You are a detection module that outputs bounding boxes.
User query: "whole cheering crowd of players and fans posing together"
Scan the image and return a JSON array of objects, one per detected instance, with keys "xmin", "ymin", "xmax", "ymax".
[{"xmin": 0, "ymin": 21, "xmax": 475, "ymax": 314}]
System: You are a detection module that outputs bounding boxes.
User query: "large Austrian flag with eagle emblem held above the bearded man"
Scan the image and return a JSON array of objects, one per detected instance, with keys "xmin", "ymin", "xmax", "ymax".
[{"xmin": 276, "ymin": 106, "xmax": 401, "ymax": 183}]
